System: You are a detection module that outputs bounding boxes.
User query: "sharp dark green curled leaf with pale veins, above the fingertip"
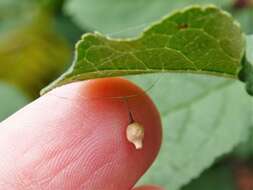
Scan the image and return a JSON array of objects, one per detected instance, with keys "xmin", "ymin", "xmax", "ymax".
[{"xmin": 41, "ymin": 6, "xmax": 244, "ymax": 94}]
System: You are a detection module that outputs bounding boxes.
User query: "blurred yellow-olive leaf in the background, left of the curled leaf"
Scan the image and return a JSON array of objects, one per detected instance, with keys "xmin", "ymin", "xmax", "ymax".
[{"xmin": 0, "ymin": 15, "xmax": 71, "ymax": 97}]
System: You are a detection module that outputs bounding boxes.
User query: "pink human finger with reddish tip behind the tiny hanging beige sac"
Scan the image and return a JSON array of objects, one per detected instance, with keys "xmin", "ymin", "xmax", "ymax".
[{"xmin": 0, "ymin": 78, "xmax": 162, "ymax": 190}]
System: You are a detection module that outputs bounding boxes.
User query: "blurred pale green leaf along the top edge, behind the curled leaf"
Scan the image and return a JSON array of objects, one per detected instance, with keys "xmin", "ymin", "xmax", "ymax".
[{"xmin": 64, "ymin": 0, "xmax": 231, "ymax": 37}]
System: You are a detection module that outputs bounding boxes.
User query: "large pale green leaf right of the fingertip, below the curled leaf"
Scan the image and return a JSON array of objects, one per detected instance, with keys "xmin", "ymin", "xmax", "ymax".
[{"xmin": 128, "ymin": 74, "xmax": 253, "ymax": 190}]
